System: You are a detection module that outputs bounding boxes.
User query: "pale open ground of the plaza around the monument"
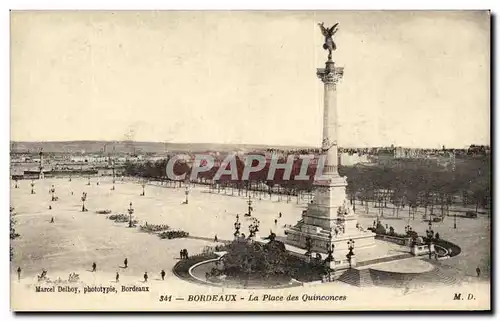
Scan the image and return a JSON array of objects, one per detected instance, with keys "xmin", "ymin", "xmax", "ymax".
[{"xmin": 11, "ymin": 177, "xmax": 490, "ymax": 309}]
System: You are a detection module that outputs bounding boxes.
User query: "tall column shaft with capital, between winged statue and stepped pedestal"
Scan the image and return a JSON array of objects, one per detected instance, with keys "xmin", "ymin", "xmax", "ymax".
[{"xmin": 316, "ymin": 59, "xmax": 344, "ymax": 177}]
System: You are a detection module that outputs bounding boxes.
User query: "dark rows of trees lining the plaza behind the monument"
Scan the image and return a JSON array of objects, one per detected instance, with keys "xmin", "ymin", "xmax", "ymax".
[{"xmin": 125, "ymin": 156, "xmax": 491, "ymax": 213}]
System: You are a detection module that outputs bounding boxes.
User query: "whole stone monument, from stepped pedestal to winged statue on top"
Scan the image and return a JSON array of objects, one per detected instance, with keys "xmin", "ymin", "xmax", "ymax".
[{"xmin": 286, "ymin": 23, "xmax": 375, "ymax": 257}]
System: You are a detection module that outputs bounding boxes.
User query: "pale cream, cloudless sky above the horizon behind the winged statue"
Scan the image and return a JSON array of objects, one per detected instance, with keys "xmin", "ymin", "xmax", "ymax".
[{"xmin": 11, "ymin": 11, "xmax": 490, "ymax": 148}]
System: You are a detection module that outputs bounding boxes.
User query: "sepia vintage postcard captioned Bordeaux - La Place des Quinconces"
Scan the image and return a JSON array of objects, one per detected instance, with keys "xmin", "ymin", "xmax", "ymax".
[{"xmin": 10, "ymin": 11, "xmax": 492, "ymax": 311}]
